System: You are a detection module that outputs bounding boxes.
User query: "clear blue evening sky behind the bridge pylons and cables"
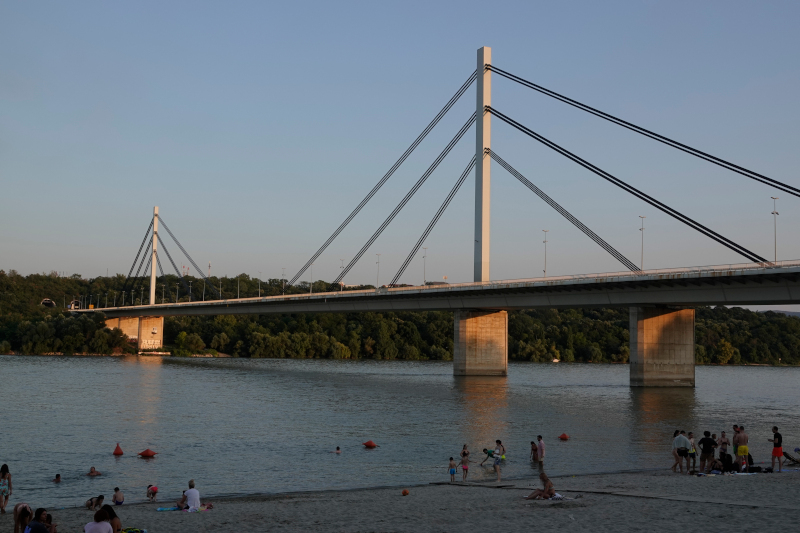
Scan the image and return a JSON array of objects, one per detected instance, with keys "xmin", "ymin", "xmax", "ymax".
[{"xmin": 0, "ymin": 1, "xmax": 800, "ymax": 304}]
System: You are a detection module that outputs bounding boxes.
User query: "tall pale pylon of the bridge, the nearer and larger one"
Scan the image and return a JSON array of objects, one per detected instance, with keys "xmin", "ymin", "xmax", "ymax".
[{"xmin": 474, "ymin": 46, "xmax": 492, "ymax": 281}]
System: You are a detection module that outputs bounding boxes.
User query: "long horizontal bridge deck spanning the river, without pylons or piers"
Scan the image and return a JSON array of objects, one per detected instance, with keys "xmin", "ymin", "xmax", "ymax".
[{"xmin": 77, "ymin": 260, "xmax": 800, "ymax": 317}]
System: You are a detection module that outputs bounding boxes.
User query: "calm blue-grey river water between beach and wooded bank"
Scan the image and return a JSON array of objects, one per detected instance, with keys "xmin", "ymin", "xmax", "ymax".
[{"xmin": 0, "ymin": 356, "xmax": 800, "ymax": 507}]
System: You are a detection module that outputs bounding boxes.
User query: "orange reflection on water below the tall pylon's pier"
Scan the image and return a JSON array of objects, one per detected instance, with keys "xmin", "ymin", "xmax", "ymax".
[{"xmin": 453, "ymin": 376, "xmax": 508, "ymax": 450}]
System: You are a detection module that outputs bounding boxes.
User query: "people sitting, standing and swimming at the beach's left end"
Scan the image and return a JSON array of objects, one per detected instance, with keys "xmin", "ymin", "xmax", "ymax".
[{"xmin": 0, "ymin": 464, "xmax": 203, "ymax": 533}]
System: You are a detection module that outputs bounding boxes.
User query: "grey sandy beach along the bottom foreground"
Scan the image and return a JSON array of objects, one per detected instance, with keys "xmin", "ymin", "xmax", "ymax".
[{"xmin": 0, "ymin": 470, "xmax": 800, "ymax": 533}]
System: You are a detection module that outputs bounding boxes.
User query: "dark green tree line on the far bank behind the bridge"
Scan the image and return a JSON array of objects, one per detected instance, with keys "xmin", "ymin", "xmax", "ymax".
[{"xmin": 0, "ymin": 270, "xmax": 800, "ymax": 365}]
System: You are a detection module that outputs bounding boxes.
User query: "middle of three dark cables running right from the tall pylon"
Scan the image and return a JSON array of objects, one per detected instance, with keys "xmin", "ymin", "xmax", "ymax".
[{"xmin": 486, "ymin": 106, "xmax": 769, "ymax": 263}]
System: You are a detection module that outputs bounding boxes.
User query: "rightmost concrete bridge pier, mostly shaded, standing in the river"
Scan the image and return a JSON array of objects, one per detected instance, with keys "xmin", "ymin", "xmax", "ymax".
[{"xmin": 630, "ymin": 307, "xmax": 694, "ymax": 387}]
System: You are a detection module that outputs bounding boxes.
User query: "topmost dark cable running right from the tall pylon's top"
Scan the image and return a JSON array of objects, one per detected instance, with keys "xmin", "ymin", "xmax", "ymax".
[{"xmin": 487, "ymin": 65, "xmax": 800, "ymax": 196}]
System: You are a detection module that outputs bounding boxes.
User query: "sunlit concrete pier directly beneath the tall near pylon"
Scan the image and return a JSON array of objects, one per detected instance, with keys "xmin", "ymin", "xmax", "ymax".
[{"xmin": 453, "ymin": 309, "xmax": 508, "ymax": 376}]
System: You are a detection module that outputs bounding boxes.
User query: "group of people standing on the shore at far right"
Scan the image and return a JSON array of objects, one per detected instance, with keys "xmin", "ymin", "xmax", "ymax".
[{"xmin": 672, "ymin": 424, "xmax": 783, "ymax": 474}]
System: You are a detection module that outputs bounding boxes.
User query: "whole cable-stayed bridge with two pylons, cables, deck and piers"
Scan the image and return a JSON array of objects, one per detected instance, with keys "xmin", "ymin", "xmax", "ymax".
[{"xmin": 78, "ymin": 47, "xmax": 800, "ymax": 387}]
